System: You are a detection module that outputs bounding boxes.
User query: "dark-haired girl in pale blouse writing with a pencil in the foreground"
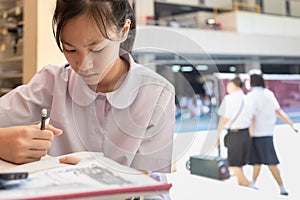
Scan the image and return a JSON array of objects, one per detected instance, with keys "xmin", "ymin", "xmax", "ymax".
[{"xmin": 0, "ymin": 0, "xmax": 175, "ymax": 177}]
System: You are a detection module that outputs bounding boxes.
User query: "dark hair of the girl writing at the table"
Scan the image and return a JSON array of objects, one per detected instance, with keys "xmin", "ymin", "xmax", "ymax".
[{"xmin": 52, "ymin": 0, "xmax": 136, "ymax": 52}]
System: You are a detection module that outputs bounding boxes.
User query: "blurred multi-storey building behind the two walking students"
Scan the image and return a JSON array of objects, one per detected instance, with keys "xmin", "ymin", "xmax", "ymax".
[{"xmin": 132, "ymin": 0, "xmax": 300, "ymax": 132}]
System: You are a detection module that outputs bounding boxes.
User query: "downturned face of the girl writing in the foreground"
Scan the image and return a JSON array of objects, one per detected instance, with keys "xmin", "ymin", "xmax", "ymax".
[{"xmin": 61, "ymin": 15, "xmax": 121, "ymax": 85}]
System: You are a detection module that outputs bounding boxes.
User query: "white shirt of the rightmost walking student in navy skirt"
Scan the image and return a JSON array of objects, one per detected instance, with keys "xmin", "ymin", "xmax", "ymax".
[{"xmin": 247, "ymin": 87, "xmax": 280, "ymax": 137}]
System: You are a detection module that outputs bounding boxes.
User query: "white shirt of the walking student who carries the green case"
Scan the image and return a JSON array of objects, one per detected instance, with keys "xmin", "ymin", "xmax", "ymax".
[{"xmin": 218, "ymin": 90, "xmax": 251, "ymax": 129}]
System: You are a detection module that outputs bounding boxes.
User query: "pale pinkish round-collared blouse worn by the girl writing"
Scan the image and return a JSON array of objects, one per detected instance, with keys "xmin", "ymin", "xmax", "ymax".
[{"xmin": 0, "ymin": 55, "xmax": 175, "ymax": 172}]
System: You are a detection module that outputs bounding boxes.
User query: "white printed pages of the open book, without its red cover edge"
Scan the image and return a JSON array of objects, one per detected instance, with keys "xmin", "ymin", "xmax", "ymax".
[{"xmin": 0, "ymin": 153, "xmax": 169, "ymax": 199}]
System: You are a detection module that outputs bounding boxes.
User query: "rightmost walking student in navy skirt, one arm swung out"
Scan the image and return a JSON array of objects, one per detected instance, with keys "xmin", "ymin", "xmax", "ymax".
[{"xmin": 247, "ymin": 74, "xmax": 298, "ymax": 195}]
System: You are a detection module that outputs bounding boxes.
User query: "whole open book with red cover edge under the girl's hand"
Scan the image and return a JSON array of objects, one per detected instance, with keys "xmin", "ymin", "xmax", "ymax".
[{"xmin": 0, "ymin": 152, "xmax": 171, "ymax": 200}]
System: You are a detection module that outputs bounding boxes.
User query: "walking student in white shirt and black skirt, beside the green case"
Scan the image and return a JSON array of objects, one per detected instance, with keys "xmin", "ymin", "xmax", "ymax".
[{"xmin": 218, "ymin": 77, "xmax": 251, "ymax": 186}]
